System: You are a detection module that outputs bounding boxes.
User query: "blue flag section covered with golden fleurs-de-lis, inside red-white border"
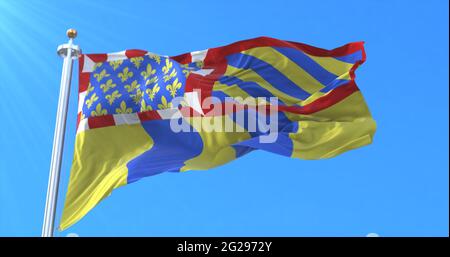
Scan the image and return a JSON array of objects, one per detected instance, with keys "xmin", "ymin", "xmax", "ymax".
[{"xmin": 82, "ymin": 54, "xmax": 195, "ymax": 118}]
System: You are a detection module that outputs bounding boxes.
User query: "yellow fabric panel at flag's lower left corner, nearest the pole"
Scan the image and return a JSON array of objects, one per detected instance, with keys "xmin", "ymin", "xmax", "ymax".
[{"xmin": 59, "ymin": 124, "xmax": 153, "ymax": 230}]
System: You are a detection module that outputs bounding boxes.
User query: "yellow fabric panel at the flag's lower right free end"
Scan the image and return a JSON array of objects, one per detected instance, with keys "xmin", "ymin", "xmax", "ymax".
[{"xmin": 289, "ymin": 91, "xmax": 376, "ymax": 159}]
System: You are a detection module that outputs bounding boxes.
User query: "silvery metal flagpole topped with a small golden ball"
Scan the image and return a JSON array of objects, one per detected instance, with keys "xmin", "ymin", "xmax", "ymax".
[{"xmin": 42, "ymin": 29, "xmax": 81, "ymax": 237}]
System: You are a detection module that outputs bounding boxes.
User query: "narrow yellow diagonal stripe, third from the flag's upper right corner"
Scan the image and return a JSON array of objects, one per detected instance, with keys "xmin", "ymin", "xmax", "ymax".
[{"xmin": 224, "ymin": 65, "xmax": 302, "ymax": 106}]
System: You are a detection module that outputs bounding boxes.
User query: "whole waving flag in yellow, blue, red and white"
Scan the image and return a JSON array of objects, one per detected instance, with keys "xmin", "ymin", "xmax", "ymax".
[{"xmin": 60, "ymin": 37, "xmax": 376, "ymax": 229}]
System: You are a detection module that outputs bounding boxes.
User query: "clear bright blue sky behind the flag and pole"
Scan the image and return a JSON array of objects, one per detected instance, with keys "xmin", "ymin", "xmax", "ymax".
[{"xmin": 0, "ymin": 0, "xmax": 449, "ymax": 236}]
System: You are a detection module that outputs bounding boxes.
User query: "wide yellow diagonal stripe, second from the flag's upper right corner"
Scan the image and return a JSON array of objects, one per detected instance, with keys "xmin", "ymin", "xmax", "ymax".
[{"xmin": 242, "ymin": 47, "xmax": 324, "ymax": 94}]
